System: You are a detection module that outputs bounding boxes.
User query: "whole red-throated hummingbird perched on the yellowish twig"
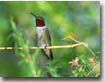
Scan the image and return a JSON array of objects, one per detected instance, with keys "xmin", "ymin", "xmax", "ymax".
[{"xmin": 31, "ymin": 13, "xmax": 53, "ymax": 60}]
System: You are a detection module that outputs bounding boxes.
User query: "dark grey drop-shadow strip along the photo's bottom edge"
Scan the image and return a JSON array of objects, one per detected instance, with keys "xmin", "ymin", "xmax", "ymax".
[{"xmin": 2, "ymin": 77, "xmax": 101, "ymax": 82}]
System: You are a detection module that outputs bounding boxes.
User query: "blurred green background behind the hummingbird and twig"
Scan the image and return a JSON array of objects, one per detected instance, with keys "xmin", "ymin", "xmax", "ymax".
[{"xmin": 0, "ymin": 1, "xmax": 100, "ymax": 77}]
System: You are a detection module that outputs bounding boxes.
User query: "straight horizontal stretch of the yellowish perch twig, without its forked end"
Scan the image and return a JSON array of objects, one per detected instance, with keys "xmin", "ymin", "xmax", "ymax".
[{"xmin": 0, "ymin": 43, "xmax": 82, "ymax": 50}]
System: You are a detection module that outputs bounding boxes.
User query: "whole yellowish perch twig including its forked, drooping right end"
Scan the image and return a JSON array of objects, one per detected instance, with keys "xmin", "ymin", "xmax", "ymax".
[{"xmin": 0, "ymin": 35, "xmax": 96, "ymax": 56}]
